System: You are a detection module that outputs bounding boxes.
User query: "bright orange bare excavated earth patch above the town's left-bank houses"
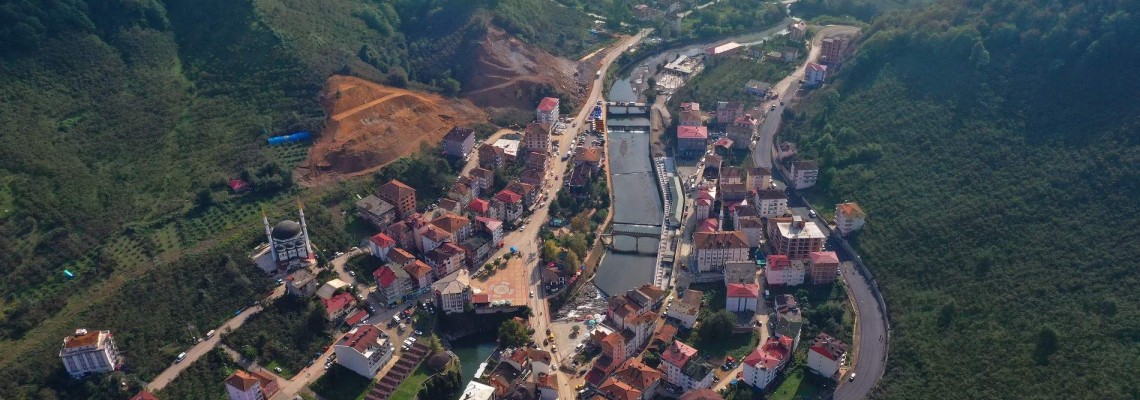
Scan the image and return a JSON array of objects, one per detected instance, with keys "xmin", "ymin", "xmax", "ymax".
[{"xmin": 294, "ymin": 75, "xmax": 487, "ymax": 186}]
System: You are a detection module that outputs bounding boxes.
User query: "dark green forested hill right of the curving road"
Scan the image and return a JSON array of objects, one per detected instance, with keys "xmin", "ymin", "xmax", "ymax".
[{"xmin": 782, "ymin": 0, "xmax": 1140, "ymax": 399}]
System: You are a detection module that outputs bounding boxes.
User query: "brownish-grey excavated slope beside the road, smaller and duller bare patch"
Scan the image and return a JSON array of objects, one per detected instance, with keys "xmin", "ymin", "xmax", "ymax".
[{"xmin": 462, "ymin": 24, "xmax": 594, "ymax": 109}]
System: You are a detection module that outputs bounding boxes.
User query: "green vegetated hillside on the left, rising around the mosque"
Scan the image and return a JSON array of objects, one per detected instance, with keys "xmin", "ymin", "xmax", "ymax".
[{"xmin": 0, "ymin": 0, "xmax": 588, "ymax": 399}]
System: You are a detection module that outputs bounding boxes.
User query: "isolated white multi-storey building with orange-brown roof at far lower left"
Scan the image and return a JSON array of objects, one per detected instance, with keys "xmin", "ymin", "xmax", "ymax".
[{"xmin": 59, "ymin": 329, "xmax": 123, "ymax": 378}]
